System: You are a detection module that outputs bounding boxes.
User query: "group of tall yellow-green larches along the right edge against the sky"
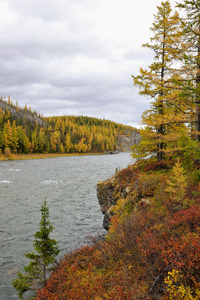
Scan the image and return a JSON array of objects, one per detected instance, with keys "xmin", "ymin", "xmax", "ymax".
[{"xmin": 132, "ymin": 0, "xmax": 200, "ymax": 161}]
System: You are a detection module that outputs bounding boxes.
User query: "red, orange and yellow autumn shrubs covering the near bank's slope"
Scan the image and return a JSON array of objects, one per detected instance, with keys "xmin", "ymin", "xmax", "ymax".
[{"xmin": 36, "ymin": 161, "xmax": 200, "ymax": 300}]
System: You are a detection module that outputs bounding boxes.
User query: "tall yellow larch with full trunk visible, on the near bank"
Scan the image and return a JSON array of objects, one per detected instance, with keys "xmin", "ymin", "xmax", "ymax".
[{"xmin": 132, "ymin": 1, "xmax": 184, "ymax": 161}]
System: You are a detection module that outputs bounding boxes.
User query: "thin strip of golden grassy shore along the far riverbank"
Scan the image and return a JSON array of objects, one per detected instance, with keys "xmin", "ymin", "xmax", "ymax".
[{"xmin": 0, "ymin": 153, "xmax": 104, "ymax": 161}]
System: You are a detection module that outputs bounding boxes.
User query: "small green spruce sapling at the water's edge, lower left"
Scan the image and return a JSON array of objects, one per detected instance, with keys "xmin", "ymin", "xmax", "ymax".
[{"xmin": 12, "ymin": 199, "xmax": 60, "ymax": 299}]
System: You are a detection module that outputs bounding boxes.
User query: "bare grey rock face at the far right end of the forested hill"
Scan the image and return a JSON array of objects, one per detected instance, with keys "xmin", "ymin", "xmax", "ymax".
[{"xmin": 117, "ymin": 130, "xmax": 141, "ymax": 152}]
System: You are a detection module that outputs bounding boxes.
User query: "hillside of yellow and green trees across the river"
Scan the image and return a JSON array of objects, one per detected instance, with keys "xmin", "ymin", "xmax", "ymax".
[{"xmin": 0, "ymin": 98, "xmax": 137, "ymax": 153}]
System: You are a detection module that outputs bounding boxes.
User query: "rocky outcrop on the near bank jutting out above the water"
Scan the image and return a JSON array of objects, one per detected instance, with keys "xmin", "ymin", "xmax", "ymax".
[{"xmin": 97, "ymin": 161, "xmax": 166, "ymax": 230}]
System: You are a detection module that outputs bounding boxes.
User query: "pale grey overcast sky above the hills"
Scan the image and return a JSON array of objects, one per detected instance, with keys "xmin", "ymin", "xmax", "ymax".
[{"xmin": 0, "ymin": 0, "xmax": 175, "ymax": 126}]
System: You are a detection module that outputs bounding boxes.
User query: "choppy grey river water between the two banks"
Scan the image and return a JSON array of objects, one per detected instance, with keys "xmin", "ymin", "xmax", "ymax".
[{"xmin": 0, "ymin": 153, "xmax": 133, "ymax": 300}]
